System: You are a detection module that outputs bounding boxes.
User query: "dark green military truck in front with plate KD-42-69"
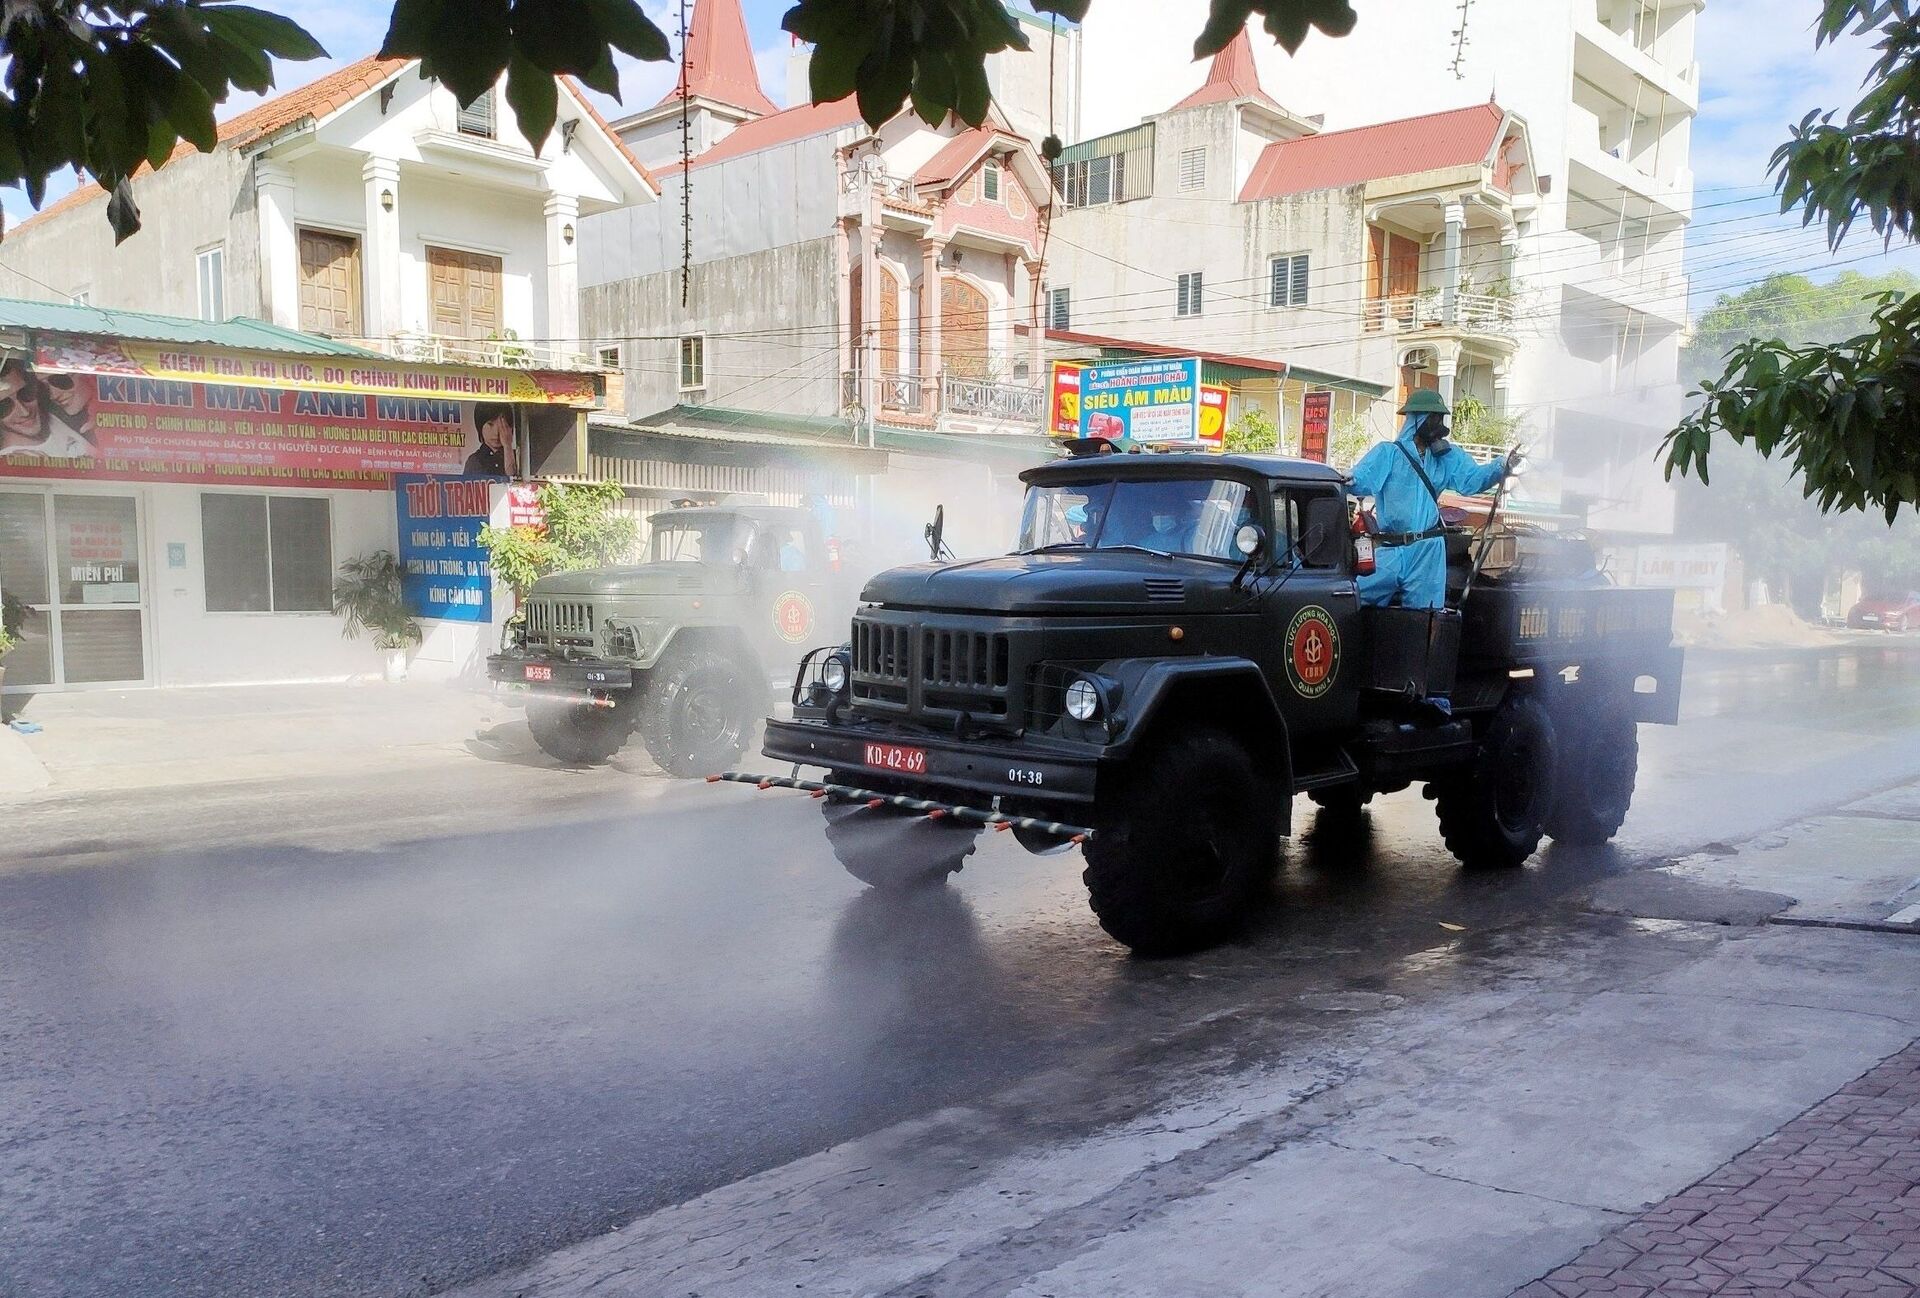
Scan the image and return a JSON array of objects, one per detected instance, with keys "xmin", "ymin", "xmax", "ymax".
[{"xmin": 732, "ymin": 453, "xmax": 1682, "ymax": 954}]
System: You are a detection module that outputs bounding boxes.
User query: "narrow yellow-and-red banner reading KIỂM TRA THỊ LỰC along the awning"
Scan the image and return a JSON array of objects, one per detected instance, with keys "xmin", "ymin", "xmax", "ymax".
[{"xmin": 35, "ymin": 334, "xmax": 599, "ymax": 405}]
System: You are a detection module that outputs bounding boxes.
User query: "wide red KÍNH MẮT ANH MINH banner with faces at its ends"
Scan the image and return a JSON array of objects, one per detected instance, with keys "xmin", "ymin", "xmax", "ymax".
[{"xmin": 0, "ymin": 363, "xmax": 533, "ymax": 490}]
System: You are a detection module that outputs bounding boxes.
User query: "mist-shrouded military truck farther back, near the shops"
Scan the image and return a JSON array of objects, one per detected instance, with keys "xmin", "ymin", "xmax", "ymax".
[{"xmin": 488, "ymin": 501, "xmax": 854, "ymax": 776}]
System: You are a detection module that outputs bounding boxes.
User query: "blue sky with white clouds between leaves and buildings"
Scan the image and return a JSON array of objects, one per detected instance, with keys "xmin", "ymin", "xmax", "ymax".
[{"xmin": 0, "ymin": 0, "xmax": 1920, "ymax": 309}]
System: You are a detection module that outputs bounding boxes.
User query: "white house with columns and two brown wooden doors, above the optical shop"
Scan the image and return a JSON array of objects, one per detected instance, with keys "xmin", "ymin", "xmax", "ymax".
[{"xmin": 0, "ymin": 58, "xmax": 655, "ymax": 365}]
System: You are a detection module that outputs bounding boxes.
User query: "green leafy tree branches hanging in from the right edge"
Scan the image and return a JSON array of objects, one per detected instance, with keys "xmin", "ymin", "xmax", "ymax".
[{"xmin": 1665, "ymin": 0, "xmax": 1920, "ymax": 522}]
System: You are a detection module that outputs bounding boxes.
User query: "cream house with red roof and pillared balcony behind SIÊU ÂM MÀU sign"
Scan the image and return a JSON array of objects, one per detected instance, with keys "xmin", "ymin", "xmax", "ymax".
[{"xmin": 1048, "ymin": 31, "xmax": 1538, "ymax": 444}]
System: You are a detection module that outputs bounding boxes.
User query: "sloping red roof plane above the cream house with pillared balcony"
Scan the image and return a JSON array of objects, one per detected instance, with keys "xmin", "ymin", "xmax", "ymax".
[{"xmin": 1240, "ymin": 104, "xmax": 1507, "ymax": 204}]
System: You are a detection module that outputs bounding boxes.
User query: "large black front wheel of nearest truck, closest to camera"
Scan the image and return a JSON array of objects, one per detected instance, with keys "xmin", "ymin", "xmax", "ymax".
[{"xmin": 1081, "ymin": 730, "xmax": 1279, "ymax": 956}]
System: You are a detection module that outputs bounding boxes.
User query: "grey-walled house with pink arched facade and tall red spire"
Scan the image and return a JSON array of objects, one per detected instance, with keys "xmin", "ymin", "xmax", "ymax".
[{"xmin": 582, "ymin": 0, "xmax": 1077, "ymax": 541}]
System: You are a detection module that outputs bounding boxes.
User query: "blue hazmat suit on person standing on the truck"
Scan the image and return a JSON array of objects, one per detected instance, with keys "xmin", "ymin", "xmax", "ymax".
[{"xmin": 1352, "ymin": 415, "xmax": 1507, "ymax": 609}]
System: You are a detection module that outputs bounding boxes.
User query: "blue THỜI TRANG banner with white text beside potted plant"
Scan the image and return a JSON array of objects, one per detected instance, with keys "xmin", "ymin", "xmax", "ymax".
[{"xmin": 394, "ymin": 474, "xmax": 499, "ymax": 622}]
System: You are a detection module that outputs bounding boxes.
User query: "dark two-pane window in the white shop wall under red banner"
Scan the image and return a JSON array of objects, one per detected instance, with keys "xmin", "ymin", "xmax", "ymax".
[{"xmin": 200, "ymin": 492, "xmax": 334, "ymax": 613}]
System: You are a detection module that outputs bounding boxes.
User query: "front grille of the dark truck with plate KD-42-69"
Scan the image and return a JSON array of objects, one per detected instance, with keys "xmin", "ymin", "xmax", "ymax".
[{"xmin": 852, "ymin": 618, "xmax": 1012, "ymax": 718}]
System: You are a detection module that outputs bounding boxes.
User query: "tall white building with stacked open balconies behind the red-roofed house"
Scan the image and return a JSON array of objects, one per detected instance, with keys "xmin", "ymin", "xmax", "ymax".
[{"xmin": 1082, "ymin": 0, "xmax": 1701, "ymax": 532}]
